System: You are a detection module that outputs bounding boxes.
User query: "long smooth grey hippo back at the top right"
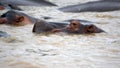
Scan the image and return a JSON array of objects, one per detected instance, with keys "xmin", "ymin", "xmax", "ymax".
[{"xmin": 59, "ymin": 1, "xmax": 120, "ymax": 13}]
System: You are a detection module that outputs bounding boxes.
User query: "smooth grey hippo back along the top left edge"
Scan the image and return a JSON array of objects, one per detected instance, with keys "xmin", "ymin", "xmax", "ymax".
[{"xmin": 0, "ymin": 0, "xmax": 56, "ymax": 6}]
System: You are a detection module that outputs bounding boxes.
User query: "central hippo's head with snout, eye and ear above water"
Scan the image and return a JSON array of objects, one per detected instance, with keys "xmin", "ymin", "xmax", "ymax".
[{"xmin": 33, "ymin": 21, "xmax": 104, "ymax": 34}]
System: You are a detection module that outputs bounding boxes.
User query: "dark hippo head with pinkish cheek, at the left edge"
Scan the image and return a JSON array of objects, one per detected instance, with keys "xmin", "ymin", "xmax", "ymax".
[{"xmin": 0, "ymin": 11, "xmax": 31, "ymax": 26}]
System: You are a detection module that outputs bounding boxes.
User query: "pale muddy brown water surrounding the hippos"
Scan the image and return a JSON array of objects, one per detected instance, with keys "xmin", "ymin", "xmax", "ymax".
[{"xmin": 0, "ymin": 0, "xmax": 120, "ymax": 68}]
